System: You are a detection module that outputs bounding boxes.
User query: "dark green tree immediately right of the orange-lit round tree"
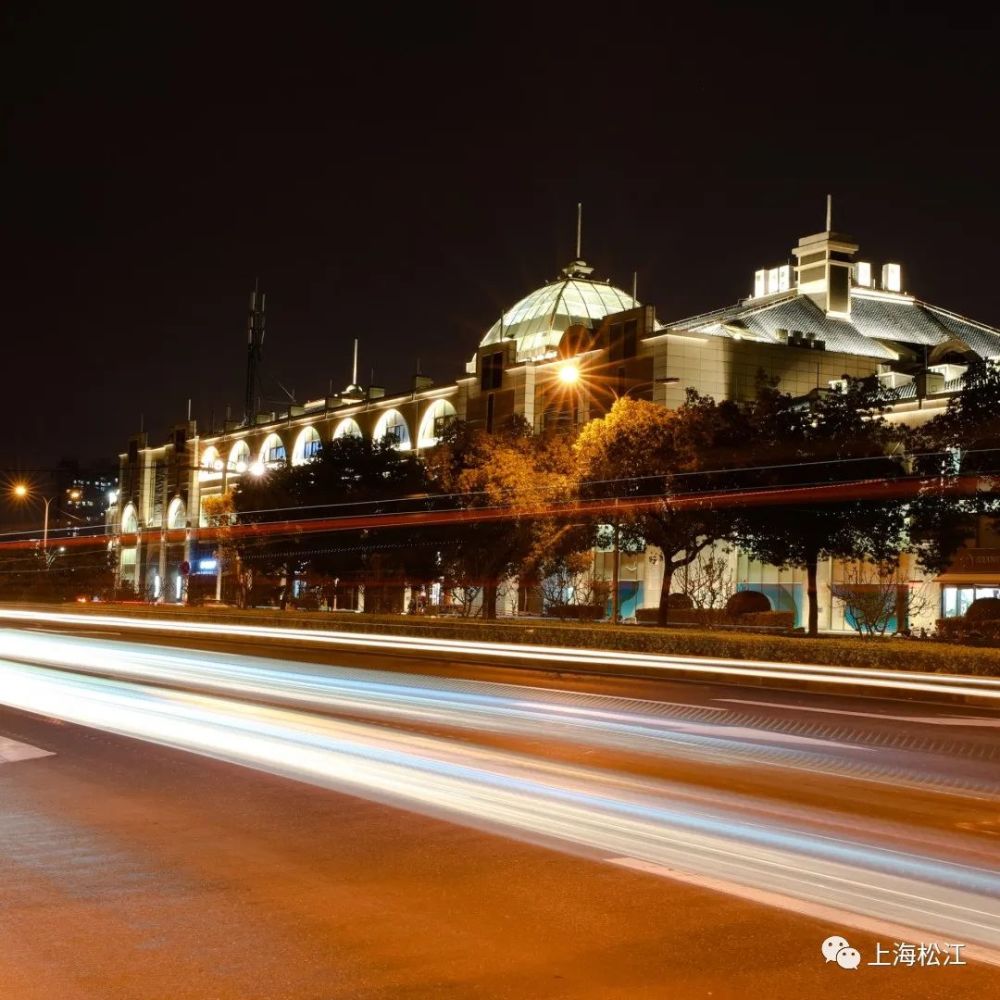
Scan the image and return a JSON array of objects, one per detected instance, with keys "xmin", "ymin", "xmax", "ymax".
[{"xmin": 734, "ymin": 377, "xmax": 907, "ymax": 635}]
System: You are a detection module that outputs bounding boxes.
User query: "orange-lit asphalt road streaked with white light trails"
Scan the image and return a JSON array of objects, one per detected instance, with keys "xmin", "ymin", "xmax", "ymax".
[{"xmin": 0, "ymin": 612, "xmax": 1000, "ymax": 1000}]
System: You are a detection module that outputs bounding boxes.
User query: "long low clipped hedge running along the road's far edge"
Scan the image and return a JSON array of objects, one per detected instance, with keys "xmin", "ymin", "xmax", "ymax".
[{"xmin": 25, "ymin": 605, "xmax": 1000, "ymax": 677}]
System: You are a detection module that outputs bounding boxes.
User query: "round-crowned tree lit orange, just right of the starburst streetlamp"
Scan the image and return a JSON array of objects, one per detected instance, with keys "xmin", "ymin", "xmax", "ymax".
[{"xmin": 576, "ymin": 389, "xmax": 739, "ymax": 625}]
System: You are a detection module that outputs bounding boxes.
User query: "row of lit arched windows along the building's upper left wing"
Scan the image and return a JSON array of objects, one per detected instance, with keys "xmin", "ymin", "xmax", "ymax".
[{"xmin": 201, "ymin": 399, "xmax": 456, "ymax": 479}]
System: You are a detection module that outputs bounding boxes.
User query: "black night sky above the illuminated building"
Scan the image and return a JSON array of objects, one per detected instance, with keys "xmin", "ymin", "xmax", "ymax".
[{"xmin": 0, "ymin": 3, "xmax": 1000, "ymax": 470}]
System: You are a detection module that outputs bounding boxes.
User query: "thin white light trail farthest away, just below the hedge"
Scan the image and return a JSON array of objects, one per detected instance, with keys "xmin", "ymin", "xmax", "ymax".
[{"xmin": 0, "ymin": 608, "xmax": 1000, "ymax": 707}]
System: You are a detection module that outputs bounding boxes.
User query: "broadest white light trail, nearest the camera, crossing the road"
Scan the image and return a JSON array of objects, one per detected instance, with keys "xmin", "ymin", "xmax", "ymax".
[{"xmin": 0, "ymin": 660, "xmax": 1000, "ymax": 964}]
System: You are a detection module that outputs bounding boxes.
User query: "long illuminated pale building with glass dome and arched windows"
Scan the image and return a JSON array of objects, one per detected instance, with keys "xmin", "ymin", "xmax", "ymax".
[{"xmin": 112, "ymin": 219, "xmax": 1000, "ymax": 630}]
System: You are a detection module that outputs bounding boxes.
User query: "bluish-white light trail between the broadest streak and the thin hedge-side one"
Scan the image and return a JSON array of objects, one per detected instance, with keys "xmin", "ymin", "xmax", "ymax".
[{"xmin": 0, "ymin": 630, "xmax": 1000, "ymax": 801}]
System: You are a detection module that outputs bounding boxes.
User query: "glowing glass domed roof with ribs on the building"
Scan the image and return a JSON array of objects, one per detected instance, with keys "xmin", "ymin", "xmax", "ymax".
[{"xmin": 479, "ymin": 260, "xmax": 639, "ymax": 361}]
